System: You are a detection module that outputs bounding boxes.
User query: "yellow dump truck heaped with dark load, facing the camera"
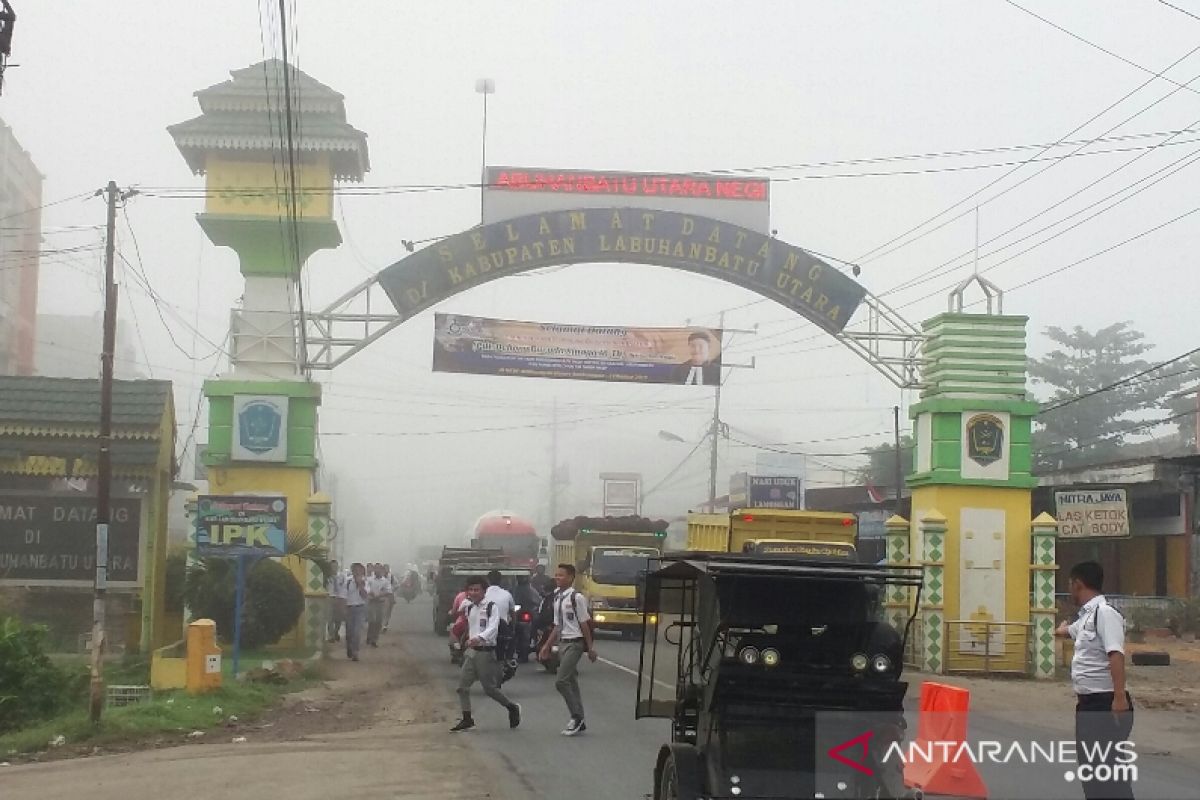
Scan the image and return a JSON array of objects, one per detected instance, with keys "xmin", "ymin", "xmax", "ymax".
[{"xmin": 551, "ymin": 517, "xmax": 667, "ymax": 638}]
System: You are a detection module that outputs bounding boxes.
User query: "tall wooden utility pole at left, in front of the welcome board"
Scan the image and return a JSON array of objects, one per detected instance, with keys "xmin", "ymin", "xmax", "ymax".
[{"xmin": 88, "ymin": 181, "xmax": 121, "ymax": 724}]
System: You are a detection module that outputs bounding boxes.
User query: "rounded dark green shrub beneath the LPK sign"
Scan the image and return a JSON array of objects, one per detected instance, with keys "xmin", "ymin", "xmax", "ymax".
[{"xmin": 184, "ymin": 559, "xmax": 304, "ymax": 649}]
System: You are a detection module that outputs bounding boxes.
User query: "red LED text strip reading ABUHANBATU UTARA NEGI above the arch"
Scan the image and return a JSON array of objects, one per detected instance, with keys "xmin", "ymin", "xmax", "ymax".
[{"xmin": 487, "ymin": 168, "xmax": 770, "ymax": 203}]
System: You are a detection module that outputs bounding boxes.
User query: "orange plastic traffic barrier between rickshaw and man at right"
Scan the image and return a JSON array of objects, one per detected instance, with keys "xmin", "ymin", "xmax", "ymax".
[{"xmin": 904, "ymin": 681, "xmax": 988, "ymax": 800}]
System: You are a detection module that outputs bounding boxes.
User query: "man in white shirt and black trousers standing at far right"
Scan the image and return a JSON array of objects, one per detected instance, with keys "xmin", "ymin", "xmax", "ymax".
[{"xmin": 1055, "ymin": 561, "xmax": 1136, "ymax": 800}]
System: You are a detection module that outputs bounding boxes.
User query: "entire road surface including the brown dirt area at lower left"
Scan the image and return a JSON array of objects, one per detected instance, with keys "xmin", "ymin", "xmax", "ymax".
[{"xmin": 9, "ymin": 599, "xmax": 1200, "ymax": 800}]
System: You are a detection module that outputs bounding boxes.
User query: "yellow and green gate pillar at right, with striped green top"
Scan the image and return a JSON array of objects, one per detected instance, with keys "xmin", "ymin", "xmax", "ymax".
[{"xmin": 908, "ymin": 312, "xmax": 1052, "ymax": 673}]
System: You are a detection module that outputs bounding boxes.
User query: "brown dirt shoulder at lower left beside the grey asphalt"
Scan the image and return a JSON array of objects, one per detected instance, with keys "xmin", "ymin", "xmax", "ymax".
[{"xmin": 0, "ymin": 637, "xmax": 520, "ymax": 800}]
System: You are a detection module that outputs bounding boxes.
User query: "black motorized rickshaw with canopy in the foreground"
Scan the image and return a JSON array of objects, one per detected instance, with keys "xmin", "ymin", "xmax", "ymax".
[{"xmin": 636, "ymin": 553, "xmax": 923, "ymax": 800}]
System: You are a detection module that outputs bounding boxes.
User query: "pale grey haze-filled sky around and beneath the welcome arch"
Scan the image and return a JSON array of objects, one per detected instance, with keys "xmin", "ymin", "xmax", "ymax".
[{"xmin": 0, "ymin": 0, "xmax": 1200, "ymax": 563}]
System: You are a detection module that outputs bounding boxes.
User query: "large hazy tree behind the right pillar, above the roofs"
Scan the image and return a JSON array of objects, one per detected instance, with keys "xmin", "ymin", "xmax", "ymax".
[{"xmin": 1030, "ymin": 323, "xmax": 1181, "ymax": 469}]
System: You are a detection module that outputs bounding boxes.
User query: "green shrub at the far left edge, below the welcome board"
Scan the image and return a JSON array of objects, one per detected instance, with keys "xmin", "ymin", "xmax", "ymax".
[{"xmin": 0, "ymin": 616, "xmax": 76, "ymax": 733}]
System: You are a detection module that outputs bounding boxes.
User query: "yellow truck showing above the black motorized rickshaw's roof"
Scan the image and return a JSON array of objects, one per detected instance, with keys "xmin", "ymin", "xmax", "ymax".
[{"xmin": 688, "ymin": 509, "xmax": 858, "ymax": 561}]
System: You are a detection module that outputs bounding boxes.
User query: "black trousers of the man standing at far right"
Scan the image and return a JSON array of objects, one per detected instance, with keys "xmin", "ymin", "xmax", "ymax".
[{"xmin": 1075, "ymin": 692, "xmax": 1136, "ymax": 800}]
